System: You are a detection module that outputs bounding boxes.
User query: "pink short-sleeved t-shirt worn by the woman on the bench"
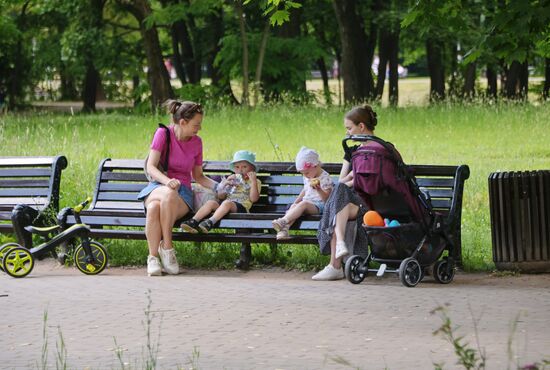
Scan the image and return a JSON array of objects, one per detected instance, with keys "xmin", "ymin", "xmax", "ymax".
[{"xmin": 151, "ymin": 125, "xmax": 202, "ymax": 189}]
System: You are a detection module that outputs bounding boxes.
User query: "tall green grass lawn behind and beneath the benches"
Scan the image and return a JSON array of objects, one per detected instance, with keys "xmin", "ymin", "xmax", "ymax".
[{"xmin": 0, "ymin": 104, "xmax": 550, "ymax": 270}]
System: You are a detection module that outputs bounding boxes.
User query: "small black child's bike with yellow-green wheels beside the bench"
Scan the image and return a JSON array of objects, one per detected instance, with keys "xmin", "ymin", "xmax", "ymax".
[{"xmin": 0, "ymin": 198, "xmax": 108, "ymax": 278}]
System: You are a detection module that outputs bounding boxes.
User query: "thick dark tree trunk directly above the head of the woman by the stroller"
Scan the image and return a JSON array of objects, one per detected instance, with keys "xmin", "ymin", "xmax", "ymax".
[{"xmin": 333, "ymin": 0, "xmax": 375, "ymax": 103}]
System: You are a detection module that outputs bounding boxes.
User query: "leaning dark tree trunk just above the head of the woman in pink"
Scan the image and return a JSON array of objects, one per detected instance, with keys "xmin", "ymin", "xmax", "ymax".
[{"xmin": 118, "ymin": 0, "xmax": 174, "ymax": 110}]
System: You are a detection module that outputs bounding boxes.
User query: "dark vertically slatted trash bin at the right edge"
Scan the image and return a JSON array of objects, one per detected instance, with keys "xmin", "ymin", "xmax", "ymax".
[{"xmin": 489, "ymin": 170, "xmax": 550, "ymax": 272}]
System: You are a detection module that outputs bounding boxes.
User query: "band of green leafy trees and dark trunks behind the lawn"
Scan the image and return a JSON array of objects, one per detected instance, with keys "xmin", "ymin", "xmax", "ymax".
[{"xmin": 0, "ymin": 0, "xmax": 550, "ymax": 111}]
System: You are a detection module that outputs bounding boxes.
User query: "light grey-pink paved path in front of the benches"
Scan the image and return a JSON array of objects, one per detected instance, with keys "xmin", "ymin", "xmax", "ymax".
[{"xmin": 0, "ymin": 261, "xmax": 550, "ymax": 369}]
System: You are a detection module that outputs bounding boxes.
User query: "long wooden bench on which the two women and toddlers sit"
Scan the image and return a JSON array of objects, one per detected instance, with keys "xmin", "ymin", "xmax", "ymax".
[{"xmin": 64, "ymin": 158, "xmax": 469, "ymax": 268}]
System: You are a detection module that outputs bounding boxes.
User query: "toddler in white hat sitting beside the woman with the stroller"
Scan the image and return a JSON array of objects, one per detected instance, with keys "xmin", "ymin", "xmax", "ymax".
[{"xmin": 272, "ymin": 146, "xmax": 334, "ymax": 240}]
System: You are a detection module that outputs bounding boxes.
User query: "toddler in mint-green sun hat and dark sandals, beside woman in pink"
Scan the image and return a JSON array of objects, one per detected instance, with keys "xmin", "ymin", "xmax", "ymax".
[{"xmin": 181, "ymin": 150, "xmax": 262, "ymax": 233}]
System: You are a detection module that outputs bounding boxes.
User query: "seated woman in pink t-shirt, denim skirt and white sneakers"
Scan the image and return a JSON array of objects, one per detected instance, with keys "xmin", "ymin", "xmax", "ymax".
[{"xmin": 138, "ymin": 100, "xmax": 217, "ymax": 276}]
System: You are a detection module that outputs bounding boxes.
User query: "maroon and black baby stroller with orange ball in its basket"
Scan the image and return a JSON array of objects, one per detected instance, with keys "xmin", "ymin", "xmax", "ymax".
[{"xmin": 342, "ymin": 135, "xmax": 455, "ymax": 287}]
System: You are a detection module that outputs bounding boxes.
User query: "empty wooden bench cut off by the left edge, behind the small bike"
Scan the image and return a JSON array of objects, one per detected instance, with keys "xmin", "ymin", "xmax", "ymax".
[{"xmin": 0, "ymin": 156, "xmax": 67, "ymax": 233}]
